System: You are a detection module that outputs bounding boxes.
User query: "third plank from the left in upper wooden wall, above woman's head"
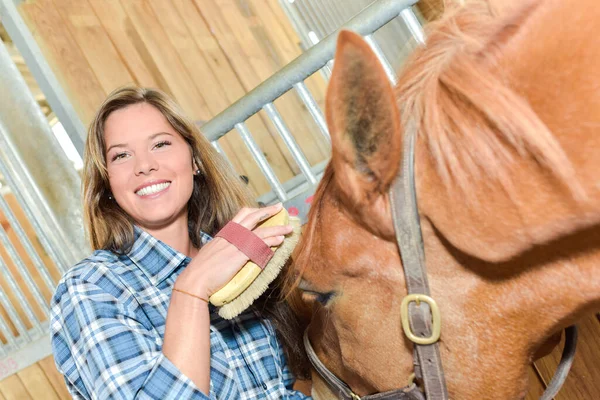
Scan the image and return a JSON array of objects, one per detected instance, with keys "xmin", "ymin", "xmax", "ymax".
[{"xmin": 89, "ymin": 0, "xmax": 161, "ymax": 90}]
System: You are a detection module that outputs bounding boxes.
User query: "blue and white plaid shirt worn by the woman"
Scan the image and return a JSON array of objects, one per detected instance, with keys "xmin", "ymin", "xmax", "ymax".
[{"xmin": 50, "ymin": 227, "xmax": 306, "ymax": 400}]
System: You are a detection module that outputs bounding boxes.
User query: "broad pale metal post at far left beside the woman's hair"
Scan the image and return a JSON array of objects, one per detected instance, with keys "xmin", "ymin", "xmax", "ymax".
[{"xmin": 0, "ymin": 38, "xmax": 88, "ymax": 270}]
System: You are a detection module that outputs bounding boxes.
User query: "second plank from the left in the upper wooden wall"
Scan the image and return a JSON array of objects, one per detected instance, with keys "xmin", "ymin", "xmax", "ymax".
[{"xmin": 57, "ymin": 0, "xmax": 133, "ymax": 93}]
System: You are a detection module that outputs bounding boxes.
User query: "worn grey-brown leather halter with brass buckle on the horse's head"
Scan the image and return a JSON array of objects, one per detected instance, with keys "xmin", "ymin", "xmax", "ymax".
[{"xmin": 304, "ymin": 122, "xmax": 580, "ymax": 400}]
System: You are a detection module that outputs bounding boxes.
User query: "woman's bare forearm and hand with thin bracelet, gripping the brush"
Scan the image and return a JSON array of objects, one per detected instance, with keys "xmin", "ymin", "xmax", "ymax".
[{"xmin": 163, "ymin": 204, "xmax": 292, "ymax": 393}]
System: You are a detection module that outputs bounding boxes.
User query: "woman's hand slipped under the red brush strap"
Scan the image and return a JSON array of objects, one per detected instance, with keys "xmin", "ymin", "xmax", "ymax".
[{"xmin": 174, "ymin": 203, "xmax": 292, "ymax": 299}]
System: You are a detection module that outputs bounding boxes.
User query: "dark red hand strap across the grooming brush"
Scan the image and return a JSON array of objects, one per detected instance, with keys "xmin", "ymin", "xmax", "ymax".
[{"xmin": 215, "ymin": 221, "xmax": 273, "ymax": 269}]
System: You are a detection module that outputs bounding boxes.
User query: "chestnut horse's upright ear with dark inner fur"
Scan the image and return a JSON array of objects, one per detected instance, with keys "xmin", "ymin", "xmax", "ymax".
[{"xmin": 326, "ymin": 31, "xmax": 402, "ymax": 202}]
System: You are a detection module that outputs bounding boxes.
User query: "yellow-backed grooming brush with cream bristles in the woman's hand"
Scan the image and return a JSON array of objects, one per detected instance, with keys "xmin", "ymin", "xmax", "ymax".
[{"xmin": 209, "ymin": 209, "xmax": 300, "ymax": 319}]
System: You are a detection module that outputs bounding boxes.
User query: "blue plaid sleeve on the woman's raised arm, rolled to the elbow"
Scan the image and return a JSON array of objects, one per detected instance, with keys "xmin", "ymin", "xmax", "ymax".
[{"xmin": 51, "ymin": 279, "xmax": 211, "ymax": 400}]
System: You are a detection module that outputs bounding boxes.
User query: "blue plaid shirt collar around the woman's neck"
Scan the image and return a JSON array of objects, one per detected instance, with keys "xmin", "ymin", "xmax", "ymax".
[{"xmin": 126, "ymin": 226, "xmax": 211, "ymax": 286}]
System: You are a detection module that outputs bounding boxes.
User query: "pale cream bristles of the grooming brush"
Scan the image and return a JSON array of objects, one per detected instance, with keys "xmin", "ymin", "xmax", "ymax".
[{"xmin": 219, "ymin": 217, "xmax": 300, "ymax": 319}]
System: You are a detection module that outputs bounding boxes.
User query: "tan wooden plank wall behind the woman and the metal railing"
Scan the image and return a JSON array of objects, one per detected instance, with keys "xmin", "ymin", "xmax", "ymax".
[{"xmin": 19, "ymin": 0, "xmax": 328, "ymax": 195}]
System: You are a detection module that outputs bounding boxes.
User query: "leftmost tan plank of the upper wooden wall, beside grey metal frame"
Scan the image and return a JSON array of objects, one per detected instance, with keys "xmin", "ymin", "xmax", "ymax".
[{"xmin": 19, "ymin": 0, "xmax": 106, "ymax": 124}]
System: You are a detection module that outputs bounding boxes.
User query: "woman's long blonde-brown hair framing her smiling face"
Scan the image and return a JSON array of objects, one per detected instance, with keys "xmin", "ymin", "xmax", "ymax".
[{"xmin": 83, "ymin": 86, "xmax": 255, "ymax": 253}]
